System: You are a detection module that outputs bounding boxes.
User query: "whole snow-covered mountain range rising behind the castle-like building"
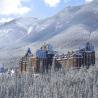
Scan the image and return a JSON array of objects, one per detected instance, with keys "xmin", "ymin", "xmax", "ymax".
[{"xmin": 0, "ymin": 0, "xmax": 98, "ymax": 65}]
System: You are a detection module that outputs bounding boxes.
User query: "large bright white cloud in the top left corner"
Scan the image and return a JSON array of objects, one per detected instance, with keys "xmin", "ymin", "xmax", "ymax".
[{"xmin": 0, "ymin": 0, "xmax": 30, "ymax": 16}]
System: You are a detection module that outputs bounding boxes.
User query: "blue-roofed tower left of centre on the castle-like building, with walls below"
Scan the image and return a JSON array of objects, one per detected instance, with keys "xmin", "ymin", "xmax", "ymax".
[{"xmin": 36, "ymin": 44, "xmax": 54, "ymax": 72}]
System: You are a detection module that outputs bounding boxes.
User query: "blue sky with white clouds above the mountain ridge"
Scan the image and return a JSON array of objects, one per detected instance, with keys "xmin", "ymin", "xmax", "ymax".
[{"xmin": 0, "ymin": 0, "xmax": 93, "ymax": 22}]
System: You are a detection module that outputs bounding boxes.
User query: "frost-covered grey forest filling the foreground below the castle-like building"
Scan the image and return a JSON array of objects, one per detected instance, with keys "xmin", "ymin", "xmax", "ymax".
[{"xmin": 0, "ymin": 66, "xmax": 98, "ymax": 98}]
